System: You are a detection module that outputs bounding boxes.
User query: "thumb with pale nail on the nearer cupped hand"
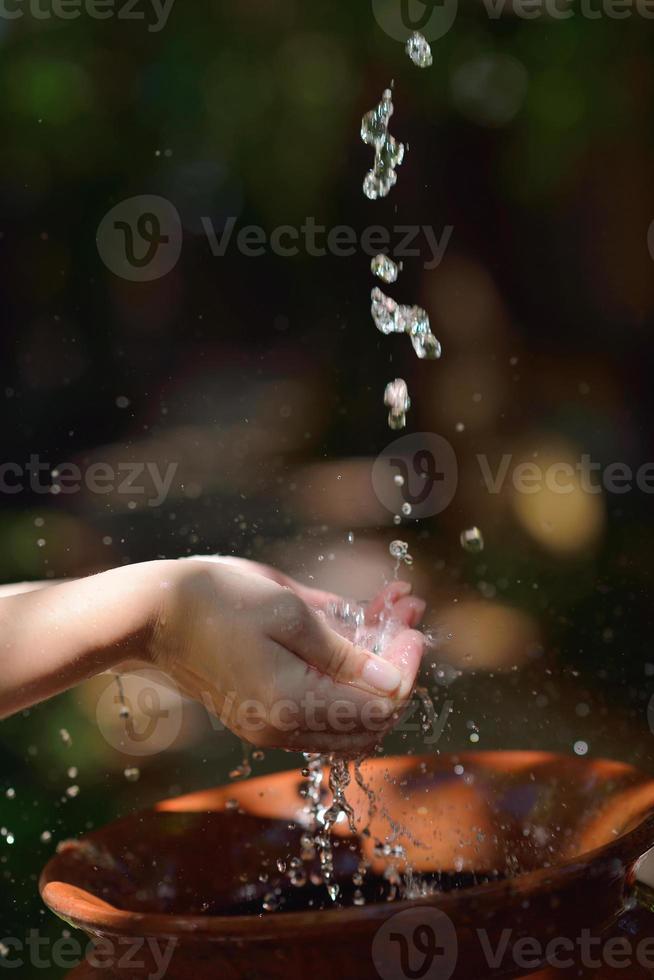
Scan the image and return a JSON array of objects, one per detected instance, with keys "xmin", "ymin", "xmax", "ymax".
[{"xmin": 268, "ymin": 592, "xmax": 402, "ymax": 697}]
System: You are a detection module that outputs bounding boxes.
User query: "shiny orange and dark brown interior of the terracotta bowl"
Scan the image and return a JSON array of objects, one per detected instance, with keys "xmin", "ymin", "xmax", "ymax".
[{"xmin": 41, "ymin": 752, "xmax": 654, "ymax": 916}]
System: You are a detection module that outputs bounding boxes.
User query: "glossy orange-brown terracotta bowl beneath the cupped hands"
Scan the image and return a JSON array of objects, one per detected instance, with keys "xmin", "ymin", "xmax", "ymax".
[{"xmin": 40, "ymin": 752, "xmax": 654, "ymax": 980}]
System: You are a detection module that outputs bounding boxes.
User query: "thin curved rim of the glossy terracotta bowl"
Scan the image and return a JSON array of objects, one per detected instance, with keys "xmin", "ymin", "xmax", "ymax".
[{"xmin": 39, "ymin": 750, "xmax": 654, "ymax": 942}]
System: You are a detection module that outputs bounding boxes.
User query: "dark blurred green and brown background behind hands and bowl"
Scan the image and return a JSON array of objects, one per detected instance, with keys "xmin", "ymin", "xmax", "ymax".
[{"xmin": 0, "ymin": 0, "xmax": 654, "ymax": 976}]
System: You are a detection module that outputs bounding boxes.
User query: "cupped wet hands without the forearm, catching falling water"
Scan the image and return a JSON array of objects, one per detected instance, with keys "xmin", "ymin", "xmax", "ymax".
[{"xmin": 150, "ymin": 559, "xmax": 425, "ymax": 754}]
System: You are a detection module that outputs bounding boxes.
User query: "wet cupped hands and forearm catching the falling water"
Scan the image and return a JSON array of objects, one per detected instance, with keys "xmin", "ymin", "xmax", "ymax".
[{"xmin": 0, "ymin": 559, "xmax": 424, "ymax": 753}]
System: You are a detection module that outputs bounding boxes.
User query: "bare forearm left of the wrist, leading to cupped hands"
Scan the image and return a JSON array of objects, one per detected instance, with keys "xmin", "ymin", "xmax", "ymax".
[{"xmin": 0, "ymin": 562, "xmax": 175, "ymax": 717}]
